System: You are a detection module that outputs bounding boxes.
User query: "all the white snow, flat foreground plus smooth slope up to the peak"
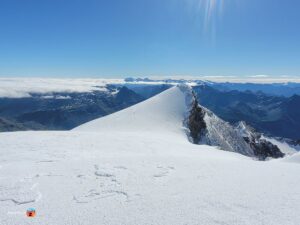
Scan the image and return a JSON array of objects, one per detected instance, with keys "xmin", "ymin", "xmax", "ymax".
[{"xmin": 0, "ymin": 87, "xmax": 300, "ymax": 225}]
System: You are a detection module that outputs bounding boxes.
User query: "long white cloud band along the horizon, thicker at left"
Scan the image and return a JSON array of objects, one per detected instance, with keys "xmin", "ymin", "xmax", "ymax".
[{"xmin": 0, "ymin": 75, "xmax": 300, "ymax": 98}]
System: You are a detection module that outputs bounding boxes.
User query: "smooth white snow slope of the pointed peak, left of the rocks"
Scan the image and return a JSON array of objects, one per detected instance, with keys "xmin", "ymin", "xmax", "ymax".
[{"xmin": 74, "ymin": 86, "xmax": 192, "ymax": 138}]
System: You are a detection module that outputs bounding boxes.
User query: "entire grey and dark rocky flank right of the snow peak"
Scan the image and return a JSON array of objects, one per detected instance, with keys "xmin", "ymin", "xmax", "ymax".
[{"xmin": 187, "ymin": 89, "xmax": 284, "ymax": 160}]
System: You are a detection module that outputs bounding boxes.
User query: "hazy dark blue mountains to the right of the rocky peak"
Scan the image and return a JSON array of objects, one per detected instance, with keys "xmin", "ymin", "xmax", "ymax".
[{"xmin": 194, "ymin": 85, "xmax": 300, "ymax": 140}]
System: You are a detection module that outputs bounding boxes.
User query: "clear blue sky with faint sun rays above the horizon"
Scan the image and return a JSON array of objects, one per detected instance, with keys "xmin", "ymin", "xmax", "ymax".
[{"xmin": 0, "ymin": 0, "xmax": 300, "ymax": 77}]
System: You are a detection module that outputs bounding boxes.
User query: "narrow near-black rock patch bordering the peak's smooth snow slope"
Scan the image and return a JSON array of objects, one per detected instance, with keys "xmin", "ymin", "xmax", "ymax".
[{"xmin": 188, "ymin": 94, "xmax": 206, "ymax": 144}]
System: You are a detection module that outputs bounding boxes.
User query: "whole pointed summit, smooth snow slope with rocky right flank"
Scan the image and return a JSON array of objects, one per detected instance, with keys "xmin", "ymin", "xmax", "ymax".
[{"xmin": 74, "ymin": 84, "xmax": 288, "ymax": 159}]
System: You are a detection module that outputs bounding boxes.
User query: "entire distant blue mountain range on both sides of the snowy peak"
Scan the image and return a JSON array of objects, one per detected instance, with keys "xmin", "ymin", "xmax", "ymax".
[{"xmin": 0, "ymin": 78, "xmax": 300, "ymax": 143}]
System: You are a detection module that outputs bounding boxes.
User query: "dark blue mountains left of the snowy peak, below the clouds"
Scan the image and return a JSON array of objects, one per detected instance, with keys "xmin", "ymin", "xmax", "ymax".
[{"xmin": 0, "ymin": 85, "xmax": 145, "ymax": 131}]
